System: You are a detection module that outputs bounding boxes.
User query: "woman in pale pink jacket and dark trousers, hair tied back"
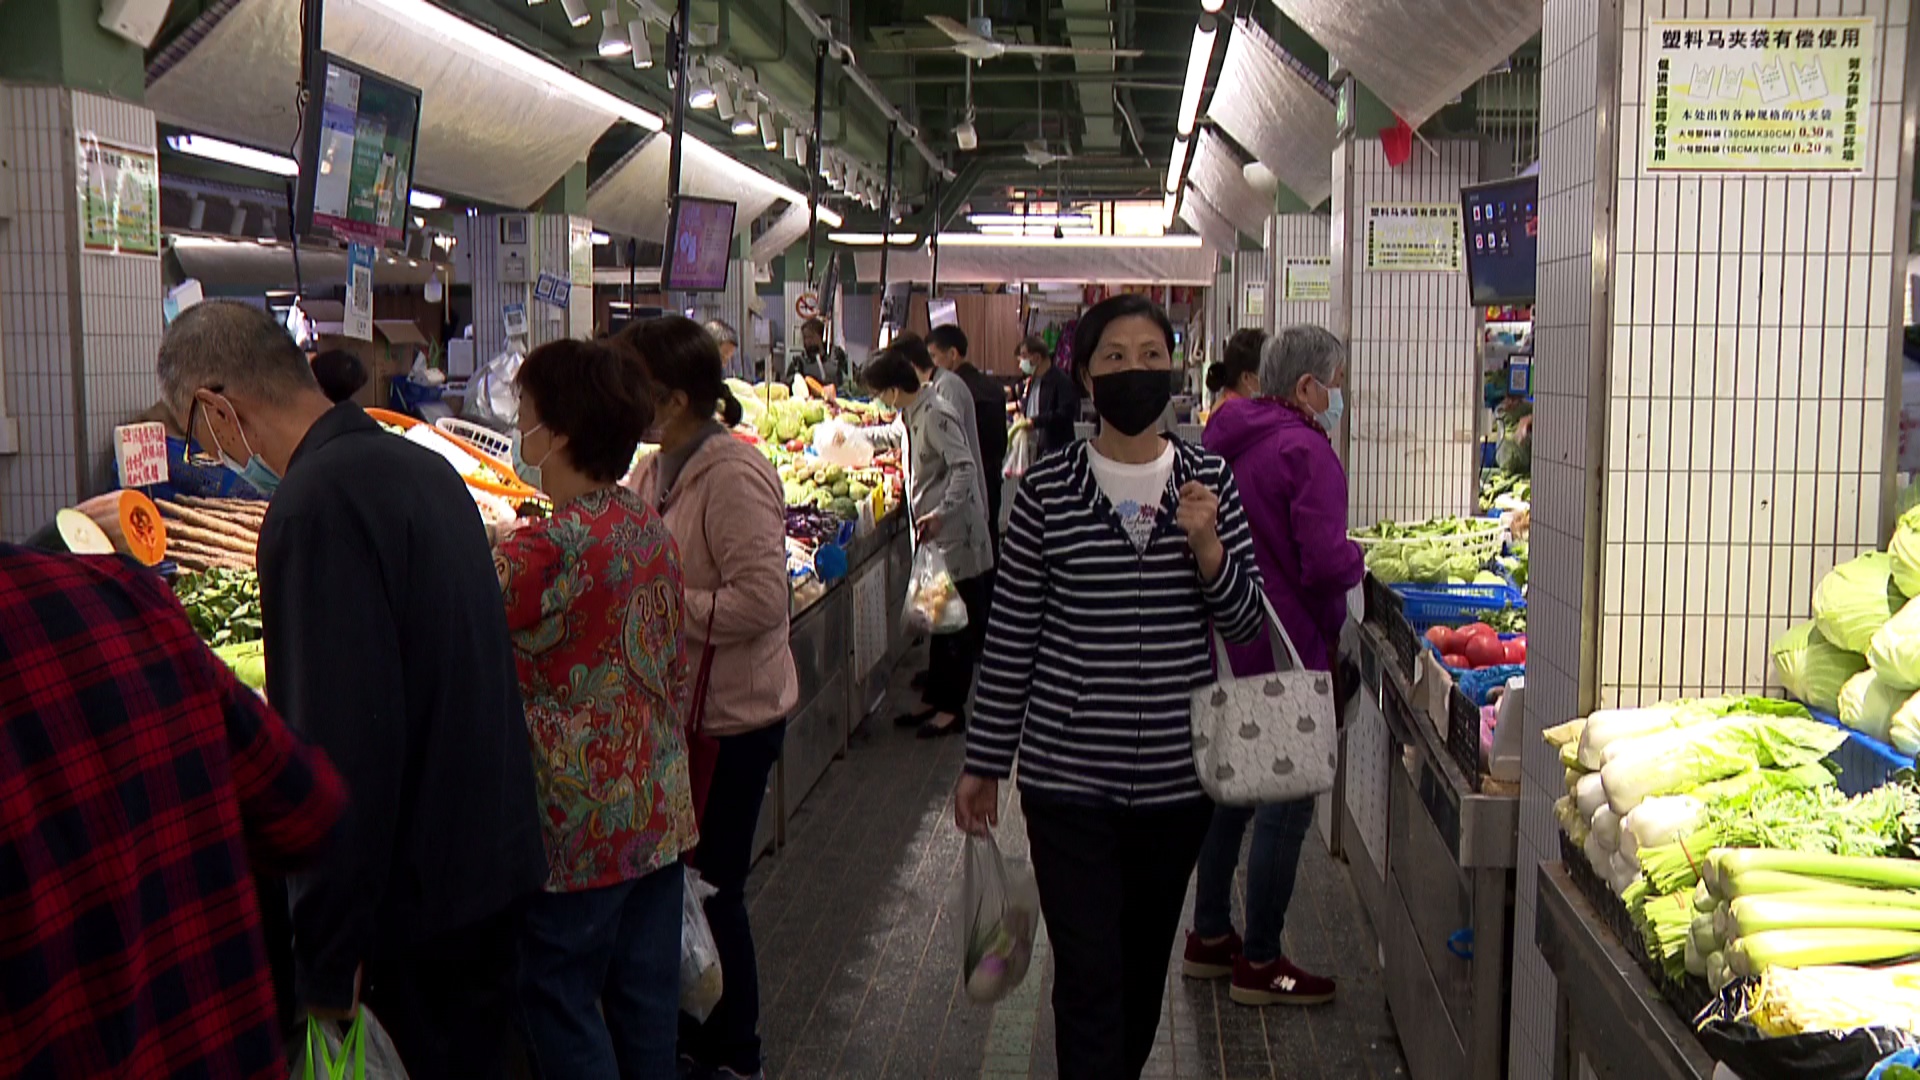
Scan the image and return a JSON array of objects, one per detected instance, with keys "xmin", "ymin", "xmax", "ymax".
[{"xmin": 618, "ymin": 315, "xmax": 799, "ymax": 1078}]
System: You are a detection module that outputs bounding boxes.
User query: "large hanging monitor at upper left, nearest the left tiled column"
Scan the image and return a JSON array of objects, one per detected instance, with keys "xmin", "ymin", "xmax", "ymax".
[{"xmin": 296, "ymin": 54, "xmax": 420, "ymax": 248}]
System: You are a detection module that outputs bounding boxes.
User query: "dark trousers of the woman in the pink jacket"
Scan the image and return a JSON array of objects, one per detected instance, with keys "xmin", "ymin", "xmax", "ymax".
[{"xmin": 680, "ymin": 721, "xmax": 787, "ymax": 1076}]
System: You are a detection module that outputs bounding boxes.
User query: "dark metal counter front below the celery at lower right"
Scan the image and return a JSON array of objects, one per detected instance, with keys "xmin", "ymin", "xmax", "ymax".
[{"xmin": 1534, "ymin": 863, "xmax": 1715, "ymax": 1080}]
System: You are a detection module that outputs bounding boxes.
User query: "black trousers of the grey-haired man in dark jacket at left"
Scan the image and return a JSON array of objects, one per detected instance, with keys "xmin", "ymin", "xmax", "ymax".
[{"xmin": 361, "ymin": 905, "xmax": 524, "ymax": 1080}]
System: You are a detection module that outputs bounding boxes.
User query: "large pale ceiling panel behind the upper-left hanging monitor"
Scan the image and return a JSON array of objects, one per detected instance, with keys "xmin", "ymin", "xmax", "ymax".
[{"xmin": 146, "ymin": 0, "xmax": 618, "ymax": 206}]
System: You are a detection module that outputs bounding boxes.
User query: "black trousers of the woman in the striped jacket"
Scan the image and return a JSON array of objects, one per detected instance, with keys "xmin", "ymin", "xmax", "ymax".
[{"xmin": 1021, "ymin": 794, "xmax": 1213, "ymax": 1080}]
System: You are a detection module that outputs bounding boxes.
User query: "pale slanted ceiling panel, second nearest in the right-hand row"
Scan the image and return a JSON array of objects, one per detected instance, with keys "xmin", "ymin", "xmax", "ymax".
[{"xmin": 1208, "ymin": 19, "xmax": 1336, "ymax": 208}]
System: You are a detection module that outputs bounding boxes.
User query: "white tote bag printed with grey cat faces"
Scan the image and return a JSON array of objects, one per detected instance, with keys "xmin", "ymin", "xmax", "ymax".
[{"xmin": 1192, "ymin": 594, "xmax": 1340, "ymax": 807}]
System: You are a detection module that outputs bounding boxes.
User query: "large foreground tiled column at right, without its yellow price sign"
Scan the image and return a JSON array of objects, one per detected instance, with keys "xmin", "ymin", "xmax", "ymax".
[{"xmin": 1509, "ymin": 0, "xmax": 1920, "ymax": 1080}]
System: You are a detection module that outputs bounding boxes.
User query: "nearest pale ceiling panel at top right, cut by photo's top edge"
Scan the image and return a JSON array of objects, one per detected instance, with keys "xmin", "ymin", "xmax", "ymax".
[{"xmin": 1269, "ymin": 0, "xmax": 1542, "ymax": 126}]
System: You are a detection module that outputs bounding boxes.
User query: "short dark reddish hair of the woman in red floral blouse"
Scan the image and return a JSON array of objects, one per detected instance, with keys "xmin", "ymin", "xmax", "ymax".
[{"xmin": 513, "ymin": 331, "xmax": 656, "ymax": 484}]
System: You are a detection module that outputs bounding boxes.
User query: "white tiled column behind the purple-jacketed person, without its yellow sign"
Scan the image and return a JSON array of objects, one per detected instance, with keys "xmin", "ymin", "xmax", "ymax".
[{"xmin": 1329, "ymin": 138, "xmax": 1480, "ymax": 528}]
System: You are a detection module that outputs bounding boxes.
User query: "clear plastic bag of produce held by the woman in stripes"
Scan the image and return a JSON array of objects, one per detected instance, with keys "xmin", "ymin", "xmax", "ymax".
[{"xmin": 956, "ymin": 836, "xmax": 1041, "ymax": 1005}]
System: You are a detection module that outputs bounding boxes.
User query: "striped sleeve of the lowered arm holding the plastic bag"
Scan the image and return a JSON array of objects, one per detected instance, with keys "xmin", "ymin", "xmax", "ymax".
[{"xmin": 966, "ymin": 475, "xmax": 1046, "ymax": 780}]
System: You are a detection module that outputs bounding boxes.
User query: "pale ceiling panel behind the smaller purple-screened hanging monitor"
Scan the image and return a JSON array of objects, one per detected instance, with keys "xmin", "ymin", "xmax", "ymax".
[{"xmin": 588, "ymin": 135, "xmax": 787, "ymax": 238}]
